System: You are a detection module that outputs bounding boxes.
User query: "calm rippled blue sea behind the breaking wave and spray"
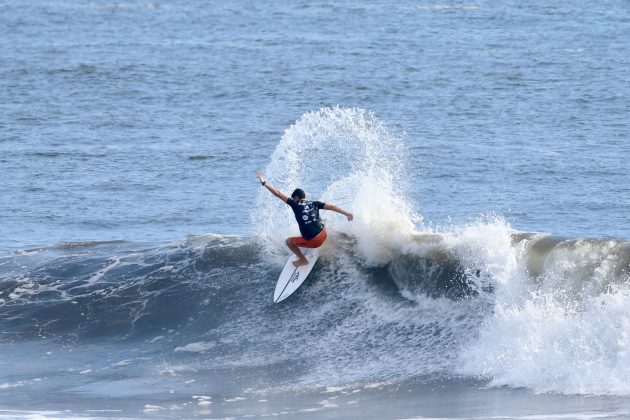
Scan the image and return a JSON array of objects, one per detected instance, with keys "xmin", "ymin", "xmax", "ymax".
[{"xmin": 0, "ymin": 1, "xmax": 630, "ymax": 250}]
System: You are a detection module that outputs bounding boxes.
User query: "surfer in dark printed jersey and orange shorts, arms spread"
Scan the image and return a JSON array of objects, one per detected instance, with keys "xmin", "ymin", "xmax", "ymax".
[{"xmin": 256, "ymin": 172, "xmax": 353, "ymax": 267}]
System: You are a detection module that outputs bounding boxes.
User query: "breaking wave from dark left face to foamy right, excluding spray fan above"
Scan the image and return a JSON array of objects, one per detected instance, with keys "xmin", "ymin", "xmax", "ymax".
[{"xmin": 0, "ymin": 225, "xmax": 630, "ymax": 395}]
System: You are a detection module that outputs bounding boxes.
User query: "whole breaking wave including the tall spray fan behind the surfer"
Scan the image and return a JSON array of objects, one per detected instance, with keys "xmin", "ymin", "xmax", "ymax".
[{"xmin": 0, "ymin": 108, "xmax": 630, "ymax": 395}]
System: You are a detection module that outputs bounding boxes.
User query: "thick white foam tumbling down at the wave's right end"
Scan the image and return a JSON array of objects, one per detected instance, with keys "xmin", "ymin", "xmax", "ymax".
[{"xmin": 458, "ymin": 233, "xmax": 630, "ymax": 395}]
